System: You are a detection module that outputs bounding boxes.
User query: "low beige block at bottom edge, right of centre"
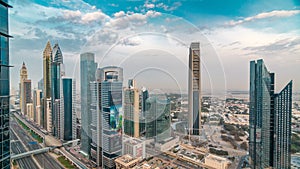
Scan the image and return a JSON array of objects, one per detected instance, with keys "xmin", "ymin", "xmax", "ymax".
[{"xmin": 204, "ymin": 154, "xmax": 231, "ymax": 169}]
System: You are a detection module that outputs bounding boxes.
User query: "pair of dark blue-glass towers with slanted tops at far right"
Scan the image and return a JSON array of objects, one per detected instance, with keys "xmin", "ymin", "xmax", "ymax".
[{"xmin": 249, "ymin": 59, "xmax": 292, "ymax": 169}]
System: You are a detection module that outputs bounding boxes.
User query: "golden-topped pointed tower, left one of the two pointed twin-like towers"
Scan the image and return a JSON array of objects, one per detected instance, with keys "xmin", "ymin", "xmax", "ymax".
[{"xmin": 43, "ymin": 41, "xmax": 52, "ymax": 133}]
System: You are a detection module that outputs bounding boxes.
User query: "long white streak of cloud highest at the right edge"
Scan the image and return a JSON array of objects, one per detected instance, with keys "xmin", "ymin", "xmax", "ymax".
[{"xmin": 225, "ymin": 10, "xmax": 300, "ymax": 26}]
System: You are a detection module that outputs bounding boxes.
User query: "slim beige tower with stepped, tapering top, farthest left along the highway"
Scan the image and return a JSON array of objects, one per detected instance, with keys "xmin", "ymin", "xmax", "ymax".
[{"xmin": 19, "ymin": 62, "xmax": 28, "ymax": 115}]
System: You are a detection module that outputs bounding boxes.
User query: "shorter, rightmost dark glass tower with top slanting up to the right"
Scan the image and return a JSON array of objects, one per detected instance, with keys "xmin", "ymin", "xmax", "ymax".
[{"xmin": 273, "ymin": 81, "xmax": 293, "ymax": 169}]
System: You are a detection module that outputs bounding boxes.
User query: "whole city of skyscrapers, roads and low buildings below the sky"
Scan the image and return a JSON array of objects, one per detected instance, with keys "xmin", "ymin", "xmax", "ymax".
[{"xmin": 0, "ymin": 0, "xmax": 300, "ymax": 169}]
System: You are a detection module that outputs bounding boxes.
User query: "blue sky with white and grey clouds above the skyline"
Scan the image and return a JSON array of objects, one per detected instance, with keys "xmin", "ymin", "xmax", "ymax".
[{"xmin": 10, "ymin": 0, "xmax": 300, "ymax": 91}]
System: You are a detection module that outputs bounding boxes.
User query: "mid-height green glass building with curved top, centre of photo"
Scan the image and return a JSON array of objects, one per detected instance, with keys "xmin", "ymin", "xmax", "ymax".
[{"xmin": 145, "ymin": 95, "xmax": 171, "ymax": 142}]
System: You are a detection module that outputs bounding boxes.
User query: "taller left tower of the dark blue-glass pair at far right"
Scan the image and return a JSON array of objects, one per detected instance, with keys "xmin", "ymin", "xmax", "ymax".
[{"xmin": 249, "ymin": 60, "xmax": 274, "ymax": 168}]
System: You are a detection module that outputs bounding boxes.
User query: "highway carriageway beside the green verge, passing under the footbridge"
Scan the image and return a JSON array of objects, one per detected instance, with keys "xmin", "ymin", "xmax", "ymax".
[{"xmin": 11, "ymin": 118, "xmax": 64, "ymax": 169}]
